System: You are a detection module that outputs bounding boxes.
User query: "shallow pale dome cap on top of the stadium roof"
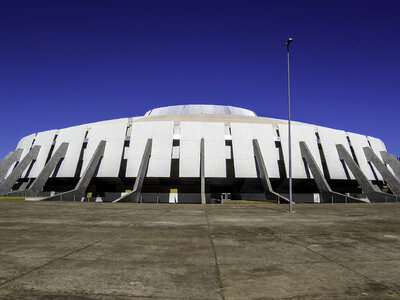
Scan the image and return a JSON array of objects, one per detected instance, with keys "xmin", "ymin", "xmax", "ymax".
[{"xmin": 145, "ymin": 104, "xmax": 257, "ymax": 117}]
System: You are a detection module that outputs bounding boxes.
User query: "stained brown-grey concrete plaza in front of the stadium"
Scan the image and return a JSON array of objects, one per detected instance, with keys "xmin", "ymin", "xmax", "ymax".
[{"xmin": 0, "ymin": 199, "xmax": 400, "ymax": 299}]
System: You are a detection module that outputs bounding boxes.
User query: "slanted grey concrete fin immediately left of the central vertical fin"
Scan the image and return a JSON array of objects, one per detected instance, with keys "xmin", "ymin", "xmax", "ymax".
[{"xmin": 113, "ymin": 139, "xmax": 153, "ymax": 203}]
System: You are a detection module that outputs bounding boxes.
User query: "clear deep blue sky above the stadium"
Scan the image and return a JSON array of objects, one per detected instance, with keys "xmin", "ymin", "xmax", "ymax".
[{"xmin": 0, "ymin": 0, "xmax": 400, "ymax": 157}]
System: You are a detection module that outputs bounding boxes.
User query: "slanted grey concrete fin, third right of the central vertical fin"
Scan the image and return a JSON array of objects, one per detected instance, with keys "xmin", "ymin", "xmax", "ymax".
[{"xmin": 336, "ymin": 144, "xmax": 397, "ymax": 202}]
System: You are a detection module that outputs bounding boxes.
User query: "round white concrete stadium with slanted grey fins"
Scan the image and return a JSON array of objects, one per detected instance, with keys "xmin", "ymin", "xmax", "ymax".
[{"xmin": 0, "ymin": 105, "xmax": 400, "ymax": 203}]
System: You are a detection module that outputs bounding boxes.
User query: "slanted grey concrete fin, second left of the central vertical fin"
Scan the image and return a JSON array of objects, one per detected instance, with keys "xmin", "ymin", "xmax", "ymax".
[{"xmin": 45, "ymin": 140, "xmax": 106, "ymax": 201}]
